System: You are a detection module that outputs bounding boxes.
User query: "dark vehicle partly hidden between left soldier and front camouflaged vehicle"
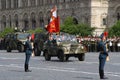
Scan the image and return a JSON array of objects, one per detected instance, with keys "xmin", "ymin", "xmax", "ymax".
[{"xmin": 33, "ymin": 33, "xmax": 47, "ymax": 56}]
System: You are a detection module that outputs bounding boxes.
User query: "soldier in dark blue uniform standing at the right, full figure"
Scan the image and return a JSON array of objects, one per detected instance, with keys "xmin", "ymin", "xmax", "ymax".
[{"xmin": 98, "ymin": 34, "xmax": 108, "ymax": 79}]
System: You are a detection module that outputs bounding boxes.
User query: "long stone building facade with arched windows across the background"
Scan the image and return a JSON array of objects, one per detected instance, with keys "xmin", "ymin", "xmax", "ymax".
[{"xmin": 0, "ymin": 0, "xmax": 120, "ymax": 34}]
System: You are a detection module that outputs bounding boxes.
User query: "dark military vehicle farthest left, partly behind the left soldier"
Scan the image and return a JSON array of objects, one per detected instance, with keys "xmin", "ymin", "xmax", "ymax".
[{"xmin": 5, "ymin": 33, "xmax": 29, "ymax": 52}]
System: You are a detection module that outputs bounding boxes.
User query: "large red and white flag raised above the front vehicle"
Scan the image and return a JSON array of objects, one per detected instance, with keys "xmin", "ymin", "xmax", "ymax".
[{"xmin": 47, "ymin": 6, "xmax": 60, "ymax": 33}]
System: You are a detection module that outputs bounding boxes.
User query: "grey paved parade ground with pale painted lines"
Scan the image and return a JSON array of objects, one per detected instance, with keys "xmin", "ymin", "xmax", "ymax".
[{"xmin": 0, "ymin": 50, "xmax": 120, "ymax": 80}]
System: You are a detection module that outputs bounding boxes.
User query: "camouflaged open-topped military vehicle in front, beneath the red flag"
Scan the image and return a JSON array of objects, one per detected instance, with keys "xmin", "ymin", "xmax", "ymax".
[{"xmin": 43, "ymin": 35, "xmax": 87, "ymax": 61}]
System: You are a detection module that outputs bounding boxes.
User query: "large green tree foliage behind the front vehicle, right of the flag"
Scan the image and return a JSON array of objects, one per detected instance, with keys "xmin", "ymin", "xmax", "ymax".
[{"xmin": 61, "ymin": 17, "xmax": 95, "ymax": 36}]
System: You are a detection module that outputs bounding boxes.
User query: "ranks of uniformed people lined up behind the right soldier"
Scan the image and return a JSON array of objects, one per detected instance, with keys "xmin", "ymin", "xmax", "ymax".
[{"xmin": 77, "ymin": 37, "xmax": 120, "ymax": 52}]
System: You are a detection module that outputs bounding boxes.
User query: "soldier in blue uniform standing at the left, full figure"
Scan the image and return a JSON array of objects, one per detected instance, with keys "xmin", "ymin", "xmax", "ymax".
[{"xmin": 24, "ymin": 35, "xmax": 33, "ymax": 72}]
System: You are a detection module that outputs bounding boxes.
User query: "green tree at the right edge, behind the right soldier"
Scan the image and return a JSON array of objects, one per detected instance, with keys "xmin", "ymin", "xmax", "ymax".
[{"xmin": 109, "ymin": 21, "xmax": 120, "ymax": 37}]
